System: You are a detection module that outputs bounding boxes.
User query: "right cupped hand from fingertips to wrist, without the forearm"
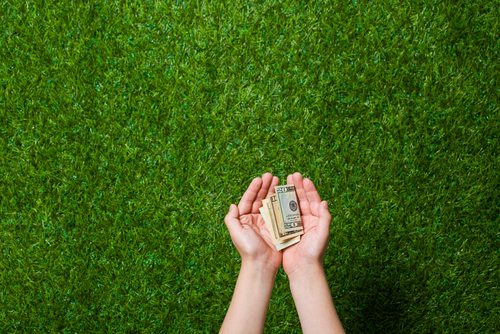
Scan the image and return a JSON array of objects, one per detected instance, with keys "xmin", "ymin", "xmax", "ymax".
[{"xmin": 283, "ymin": 173, "xmax": 332, "ymax": 276}]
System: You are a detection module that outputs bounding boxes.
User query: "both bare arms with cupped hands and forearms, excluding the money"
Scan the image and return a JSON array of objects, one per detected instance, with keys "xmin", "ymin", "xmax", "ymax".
[{"xmin": 220, "ymin": 173, "xmax": 344, "ymax": 333}]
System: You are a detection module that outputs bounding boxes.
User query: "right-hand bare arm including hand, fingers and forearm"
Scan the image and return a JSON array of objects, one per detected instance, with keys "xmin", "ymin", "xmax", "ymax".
[{"xmin": 283, "ymin": 173, "xmax": 345, "ymax": 333}]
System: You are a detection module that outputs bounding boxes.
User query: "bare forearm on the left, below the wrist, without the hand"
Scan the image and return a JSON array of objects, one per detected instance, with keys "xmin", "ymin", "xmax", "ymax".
[{"xmin": 220, "ymin": 263, "xmax": 276, "ymax": 333}]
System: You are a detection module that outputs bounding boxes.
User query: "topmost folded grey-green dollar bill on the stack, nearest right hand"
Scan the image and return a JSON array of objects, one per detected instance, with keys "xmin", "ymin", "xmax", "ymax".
[{"xmin": 274, "ymin": 184, "xmax": 304, "ymax": 232}]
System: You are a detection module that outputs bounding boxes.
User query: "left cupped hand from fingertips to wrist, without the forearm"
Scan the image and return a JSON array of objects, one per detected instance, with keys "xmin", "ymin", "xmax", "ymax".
[{"xmin": 224, "ymin": 173, "xmax": 282, "ymax": 273}]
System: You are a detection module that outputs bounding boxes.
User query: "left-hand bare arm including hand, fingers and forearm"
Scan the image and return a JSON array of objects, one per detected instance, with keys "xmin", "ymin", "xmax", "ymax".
[{"xmin": 220, "ymin": 173, "xmax": 282, "ymax": 333}]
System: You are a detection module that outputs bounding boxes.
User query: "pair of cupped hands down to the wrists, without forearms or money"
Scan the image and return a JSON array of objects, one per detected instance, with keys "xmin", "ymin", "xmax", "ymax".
[{"xmin": 224, "ymin": 173, "xmax": 331, "ymax": 276}]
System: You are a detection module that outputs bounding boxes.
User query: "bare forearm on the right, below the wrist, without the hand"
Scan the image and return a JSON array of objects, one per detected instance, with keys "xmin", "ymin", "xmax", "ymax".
[{"xmin": 289, "ymin": 264, "xmax": 345, "ymax": 334}]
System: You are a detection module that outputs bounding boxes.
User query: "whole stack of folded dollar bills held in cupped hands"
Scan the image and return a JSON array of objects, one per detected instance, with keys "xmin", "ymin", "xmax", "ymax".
[{"xmin": 260, "ymin": 184, "xmax": 304, "ymax": 250}]
